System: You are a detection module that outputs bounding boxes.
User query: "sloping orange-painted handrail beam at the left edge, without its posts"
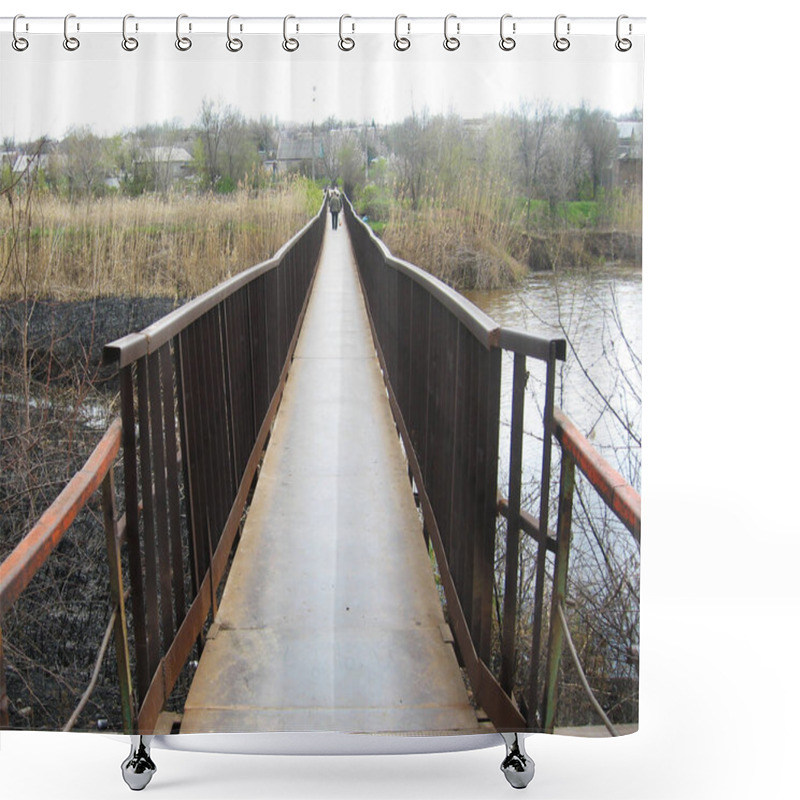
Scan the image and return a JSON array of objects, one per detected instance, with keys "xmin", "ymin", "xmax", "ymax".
[{"xmin": 0, "ymin": 419, "xmax": 122, "ymax": 618}]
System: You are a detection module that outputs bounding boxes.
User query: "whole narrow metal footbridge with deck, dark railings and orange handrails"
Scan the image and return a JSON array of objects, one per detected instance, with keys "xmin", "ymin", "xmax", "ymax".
[{"xmin": 0, "ymin": 195, "xmax": 641, "ymax": 734}]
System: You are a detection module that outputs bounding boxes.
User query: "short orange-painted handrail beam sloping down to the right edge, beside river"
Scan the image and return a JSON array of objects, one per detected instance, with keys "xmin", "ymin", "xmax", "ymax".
[{"xmin": 553, "ymin": 408, "xmax": 642, "ymax": 544}]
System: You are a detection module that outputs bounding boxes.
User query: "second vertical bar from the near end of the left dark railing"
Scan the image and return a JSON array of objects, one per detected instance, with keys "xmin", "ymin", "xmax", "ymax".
[{"xmin": 137, "ymin": 356, "xmax": 160, "ymax": 684}]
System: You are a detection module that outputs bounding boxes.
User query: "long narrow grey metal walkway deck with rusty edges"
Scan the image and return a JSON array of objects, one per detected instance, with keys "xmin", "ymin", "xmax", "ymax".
[{"xmin": 181, "ymin": 216, "xmax": 486, "ymax": 733}]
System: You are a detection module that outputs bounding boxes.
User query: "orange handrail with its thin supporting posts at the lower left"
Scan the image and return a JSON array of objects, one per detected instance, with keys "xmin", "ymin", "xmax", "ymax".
[{"xmin": 0, "ymin": 419, "xmax": 133, "ymax": 732}]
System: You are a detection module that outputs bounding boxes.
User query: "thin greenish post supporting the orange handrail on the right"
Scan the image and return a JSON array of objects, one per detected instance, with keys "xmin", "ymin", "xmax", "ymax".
[{"xmin": 542, "ymin": 450, "xmax": 575, "ymax": 733}]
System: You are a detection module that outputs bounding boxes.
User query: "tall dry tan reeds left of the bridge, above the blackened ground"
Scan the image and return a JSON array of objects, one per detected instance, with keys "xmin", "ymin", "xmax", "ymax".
[{"xmin": 0, "ymin": 181, "xmax": 321, "ymax": 300}]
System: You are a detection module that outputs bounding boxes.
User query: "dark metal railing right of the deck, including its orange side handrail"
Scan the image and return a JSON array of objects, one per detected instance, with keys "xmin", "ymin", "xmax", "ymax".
[{"xmin": 345, "ymin": 202, "xmax": 638, "ymax": 731}]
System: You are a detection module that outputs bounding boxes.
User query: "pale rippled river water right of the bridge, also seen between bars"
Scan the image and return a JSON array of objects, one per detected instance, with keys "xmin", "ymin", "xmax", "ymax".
[{"xmin": 466, "ymin": 267, "xmax": 642, "ymax": 489}]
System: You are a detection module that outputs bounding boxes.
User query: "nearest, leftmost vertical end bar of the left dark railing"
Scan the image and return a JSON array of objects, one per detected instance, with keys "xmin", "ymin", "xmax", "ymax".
[{"xmin": 120, "ymin": 364, "xmax": 150, "ymax": 700}]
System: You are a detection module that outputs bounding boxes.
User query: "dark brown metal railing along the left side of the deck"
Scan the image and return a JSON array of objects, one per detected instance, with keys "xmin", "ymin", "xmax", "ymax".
[{"xmin": 105, "ymin": 207, "xmax": 325, "ymax": 734}]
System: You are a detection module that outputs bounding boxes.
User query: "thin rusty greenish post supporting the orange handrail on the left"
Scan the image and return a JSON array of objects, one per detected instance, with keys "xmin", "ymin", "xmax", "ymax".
[{"xmin": 102, "ymin": 467, "xmax": 134, "ymax": 734}]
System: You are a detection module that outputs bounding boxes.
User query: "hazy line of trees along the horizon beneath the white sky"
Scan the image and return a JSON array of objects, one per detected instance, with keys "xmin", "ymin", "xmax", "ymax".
[{"xmin": 3, "ymin": 100, "xmax": 641, "ymax": 227}]
